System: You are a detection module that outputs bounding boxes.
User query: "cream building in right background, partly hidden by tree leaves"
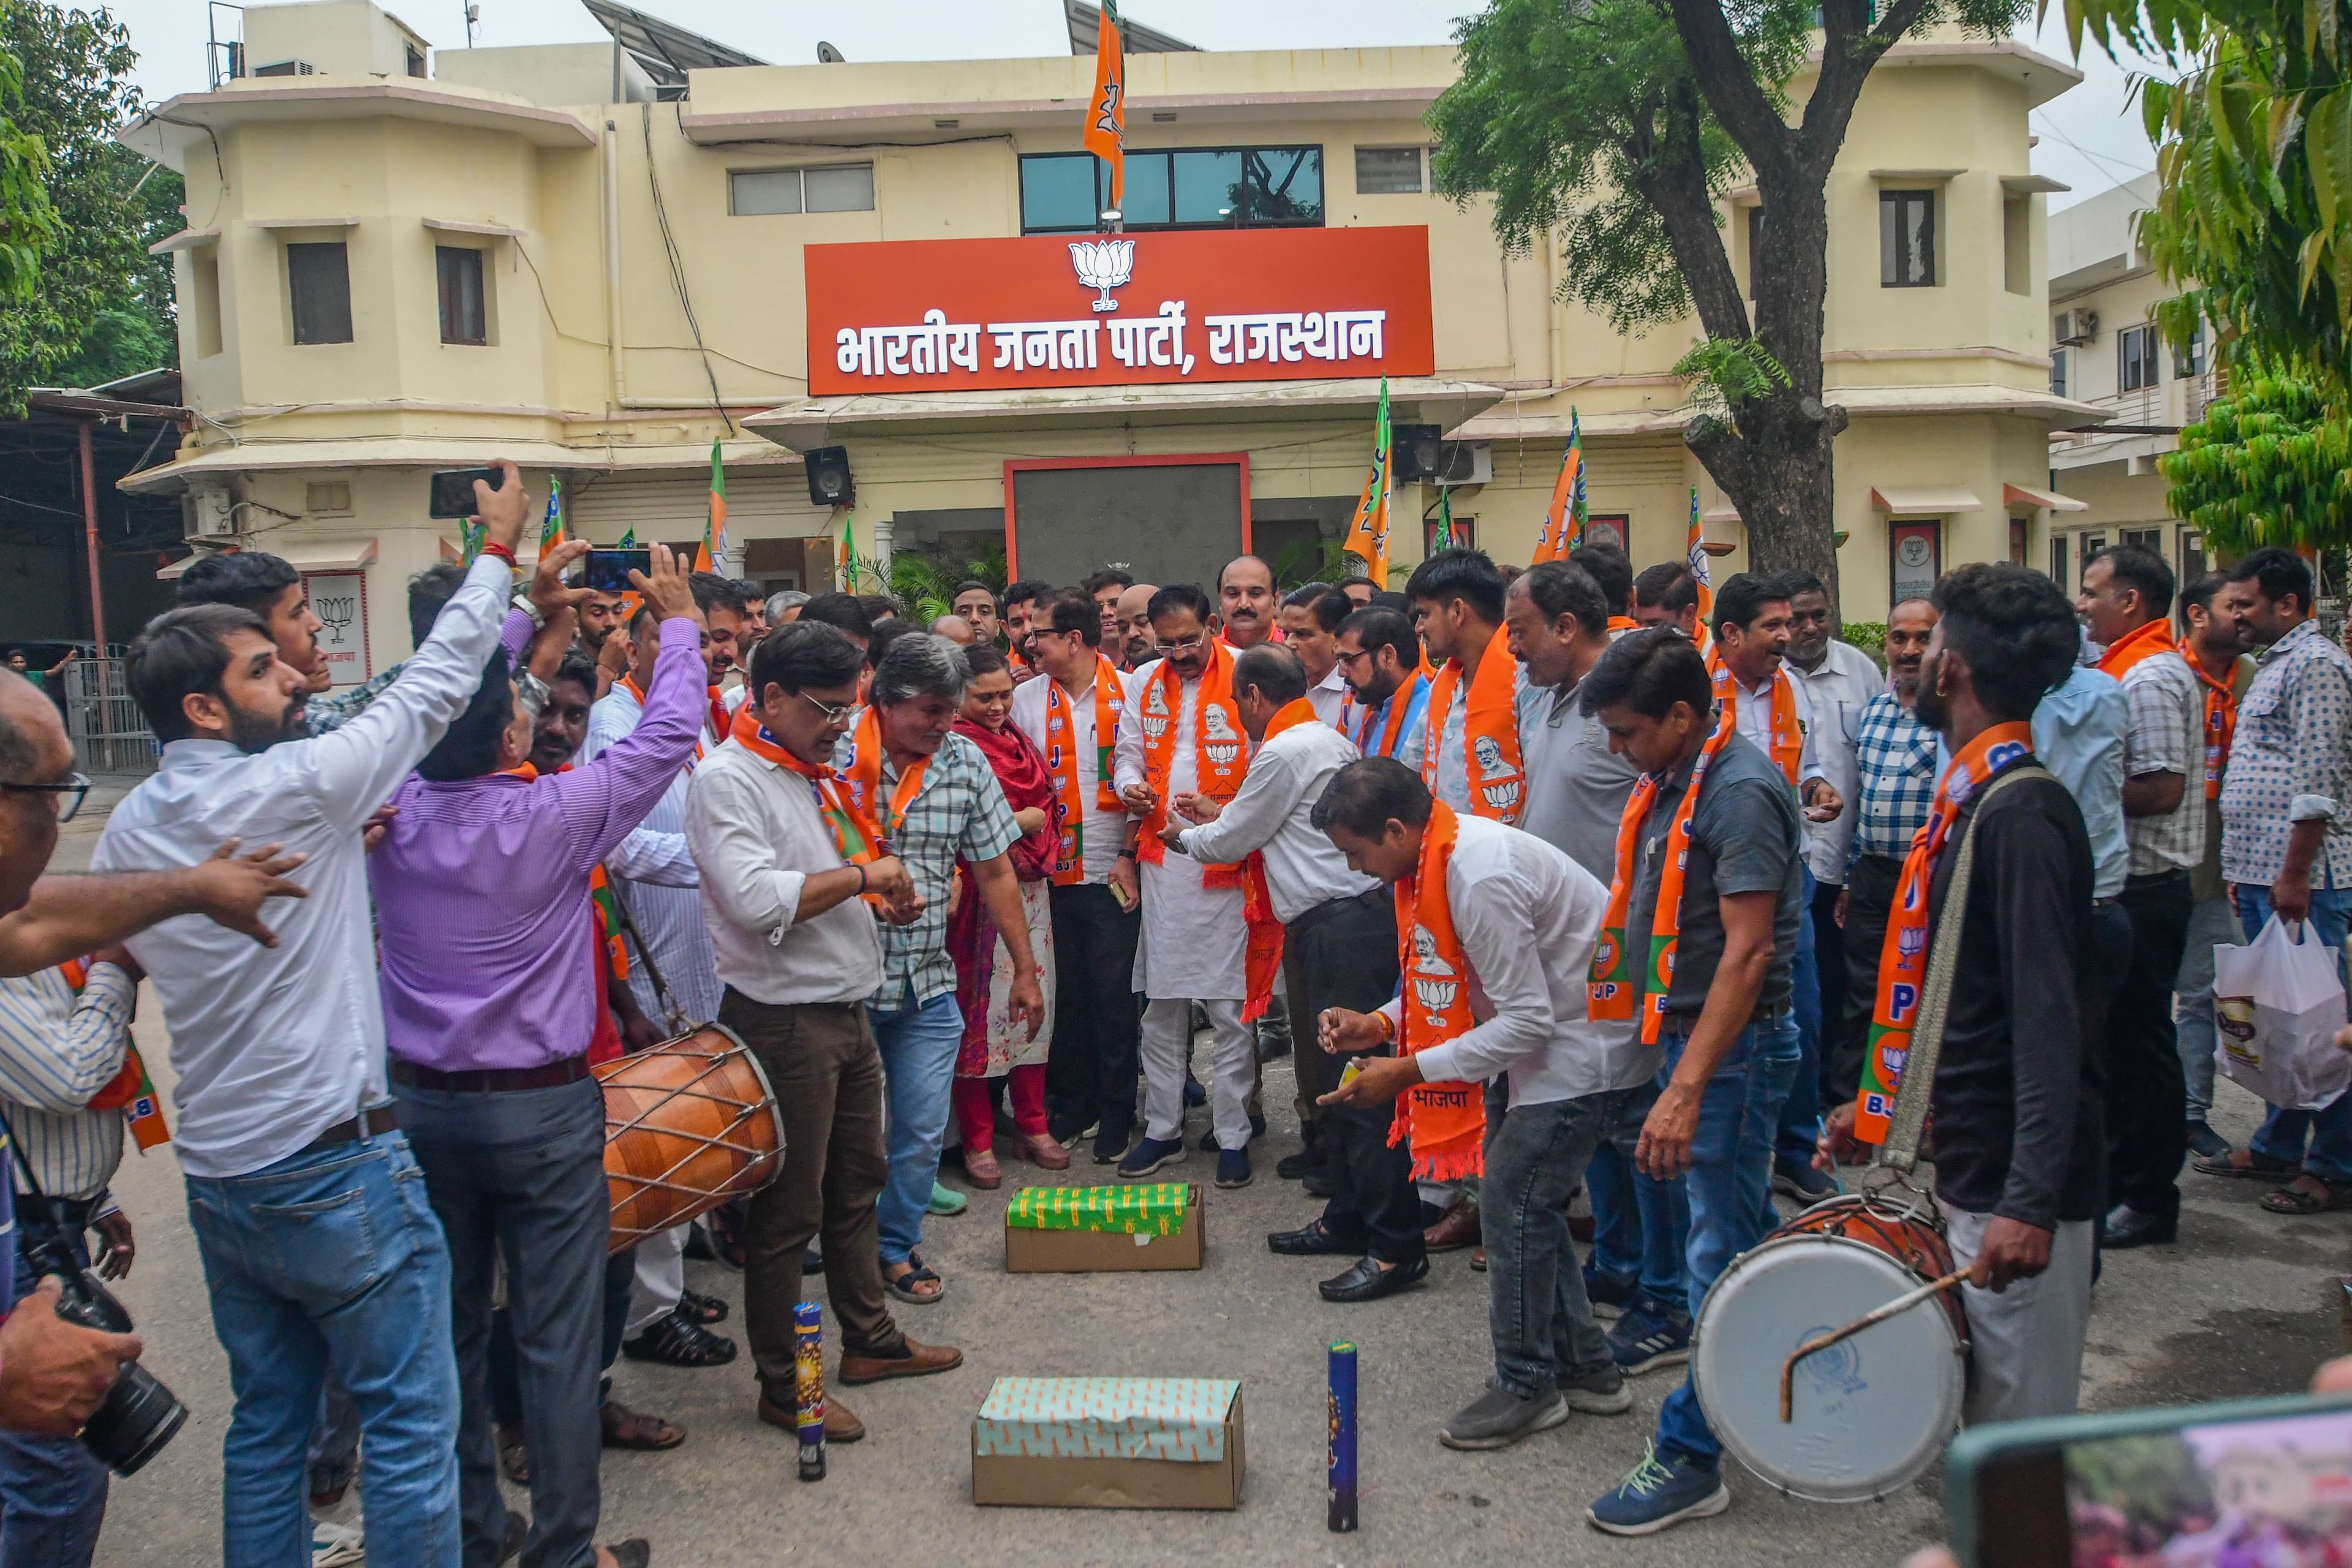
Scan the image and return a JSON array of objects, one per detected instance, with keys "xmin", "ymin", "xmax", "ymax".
[{"xmin": 2035, "ymin": 174, "xmax": 2223, "ymax": 592}]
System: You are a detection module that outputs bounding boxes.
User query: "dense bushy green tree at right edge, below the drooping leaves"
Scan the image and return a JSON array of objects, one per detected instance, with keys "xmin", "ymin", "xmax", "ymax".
[{"xmin": 2157, "ymin": 357, "xmax": 2352, "ymax": 555}]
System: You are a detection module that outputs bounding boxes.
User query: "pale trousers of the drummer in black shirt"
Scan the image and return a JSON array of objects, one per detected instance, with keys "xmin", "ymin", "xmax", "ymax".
[{"xmin": 1943, "ymin": 1208, "xmax": 2094, "ymax": 1427}]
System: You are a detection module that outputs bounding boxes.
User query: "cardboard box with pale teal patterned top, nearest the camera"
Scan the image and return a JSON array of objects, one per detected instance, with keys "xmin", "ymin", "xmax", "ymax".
[{"xmin": 971, "ymin": 1378, "xmax": 1244, "ymax": 1509}]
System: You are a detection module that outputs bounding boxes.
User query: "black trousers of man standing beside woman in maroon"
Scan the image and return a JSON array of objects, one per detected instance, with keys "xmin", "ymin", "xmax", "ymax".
[{"xmin": 1044, "ymin": 881, "xmax": 1143, "ymax": 1138}]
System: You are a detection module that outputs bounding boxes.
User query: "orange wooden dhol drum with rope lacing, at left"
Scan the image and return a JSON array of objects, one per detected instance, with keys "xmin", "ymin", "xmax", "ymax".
[{"xmin": 595, "ymin": 1023, "xmax": 783, "ymax": 1253}]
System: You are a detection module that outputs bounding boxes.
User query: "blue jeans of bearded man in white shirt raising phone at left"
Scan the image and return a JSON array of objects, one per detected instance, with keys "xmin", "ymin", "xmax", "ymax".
[{"xmin": 186, "ymin": 1131, "xmax": 459, "ymax": 1568}]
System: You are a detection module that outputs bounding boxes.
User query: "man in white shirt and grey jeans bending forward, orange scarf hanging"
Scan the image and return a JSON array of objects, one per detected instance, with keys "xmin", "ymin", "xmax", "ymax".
[{"xmin": 1315, "ymin": 757, "xmax": 1658, "ymax": 1448}]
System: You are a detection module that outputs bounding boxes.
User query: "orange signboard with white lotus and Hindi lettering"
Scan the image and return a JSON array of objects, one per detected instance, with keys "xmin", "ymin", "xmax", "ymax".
[{"xmin": 807, "ymin": 225, "xmax": 1437, "ymax": 395}]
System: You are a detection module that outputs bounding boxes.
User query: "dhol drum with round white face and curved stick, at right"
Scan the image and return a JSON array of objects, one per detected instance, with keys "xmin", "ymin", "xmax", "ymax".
[{"xmin": 1691, "ymin": 1192, "xmax": 1969, "ymax": 1502}]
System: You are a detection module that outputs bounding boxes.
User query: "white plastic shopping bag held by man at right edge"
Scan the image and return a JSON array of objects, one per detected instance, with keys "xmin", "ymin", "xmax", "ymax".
[{"xmin": 2213, "ymin": 914, "xmax": 2352, "ymax": 1110}]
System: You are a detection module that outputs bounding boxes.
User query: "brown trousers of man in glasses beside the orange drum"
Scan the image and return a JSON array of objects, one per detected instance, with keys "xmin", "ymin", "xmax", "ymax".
[{"xmin": 720, "ymin": 987, "xmax": 905, "ymax": 1403}]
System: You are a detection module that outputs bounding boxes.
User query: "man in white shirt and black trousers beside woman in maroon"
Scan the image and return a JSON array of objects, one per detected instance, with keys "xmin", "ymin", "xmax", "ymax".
[{"xmin": 1014, "ymin": 595, "xmax": 1143, "ymax": 1166}]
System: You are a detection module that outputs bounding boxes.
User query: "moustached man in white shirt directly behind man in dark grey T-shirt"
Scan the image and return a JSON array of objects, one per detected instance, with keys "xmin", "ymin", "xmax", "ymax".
[{"xmin": 1708, "ymin": 571, "xmax": 1851, "ymax": 1204}]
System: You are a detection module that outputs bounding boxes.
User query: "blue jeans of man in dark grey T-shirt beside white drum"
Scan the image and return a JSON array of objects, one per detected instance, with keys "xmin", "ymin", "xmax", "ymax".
[{"xmin": 1658, "ymin": 1013, "xmax": 1800, "ymax": 1467}]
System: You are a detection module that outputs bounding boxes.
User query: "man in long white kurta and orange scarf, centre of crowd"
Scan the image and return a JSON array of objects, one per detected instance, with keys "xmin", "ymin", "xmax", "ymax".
[{"xmin": 1115, "ymin": 583, "xmax": 1258, "ymax": 1187}]
